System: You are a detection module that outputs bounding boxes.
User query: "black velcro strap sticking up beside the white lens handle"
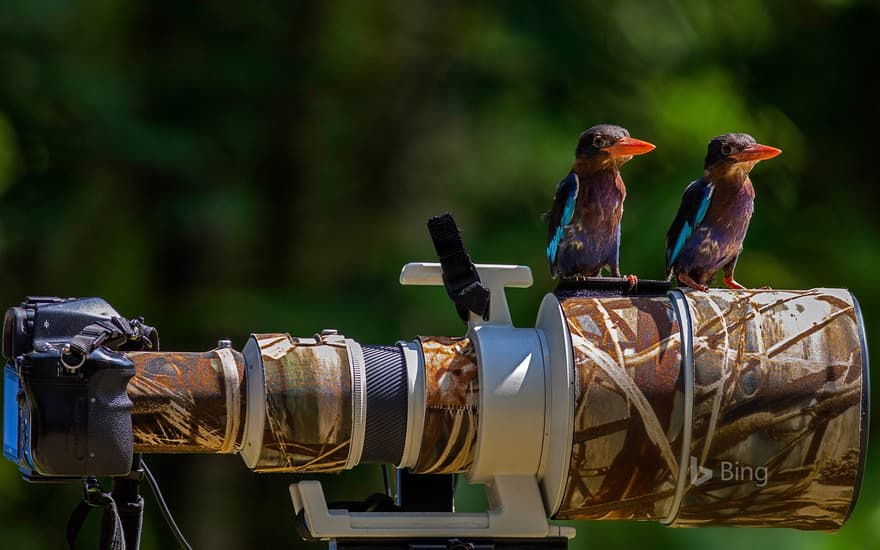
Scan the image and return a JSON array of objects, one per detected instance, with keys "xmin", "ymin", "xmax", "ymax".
[{"xmin": 428, "ymin": 212, "xmax": 490, "ymax": 321}]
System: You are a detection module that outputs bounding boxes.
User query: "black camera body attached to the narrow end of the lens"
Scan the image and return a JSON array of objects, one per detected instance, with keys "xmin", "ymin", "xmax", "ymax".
[{"xmin": 3, "ymin": 298, "xmax": 135, "ymax": 481}]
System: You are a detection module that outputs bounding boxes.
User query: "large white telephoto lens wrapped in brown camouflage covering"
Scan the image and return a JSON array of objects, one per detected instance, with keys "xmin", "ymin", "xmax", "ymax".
[{"xmin": 128, "ymin": 289, "xmax": 868, "ymax": 531}]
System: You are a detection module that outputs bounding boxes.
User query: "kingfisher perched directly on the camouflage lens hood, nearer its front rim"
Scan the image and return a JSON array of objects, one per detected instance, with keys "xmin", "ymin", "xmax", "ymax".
[{"xmin": 666, "ymin": 134, "xmax": 782, "ymax": 291}]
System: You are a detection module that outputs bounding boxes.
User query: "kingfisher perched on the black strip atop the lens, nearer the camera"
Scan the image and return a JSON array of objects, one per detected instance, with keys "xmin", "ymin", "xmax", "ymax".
[{"xmin": 547, "ymin": 124, "xmax": 654, "ymax": 287}]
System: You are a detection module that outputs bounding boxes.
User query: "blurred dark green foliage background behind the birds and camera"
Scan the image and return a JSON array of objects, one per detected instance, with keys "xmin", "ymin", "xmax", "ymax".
[{"xmin": 0, "ymin": 0, "xmax": 880, "ymax": 550}]
